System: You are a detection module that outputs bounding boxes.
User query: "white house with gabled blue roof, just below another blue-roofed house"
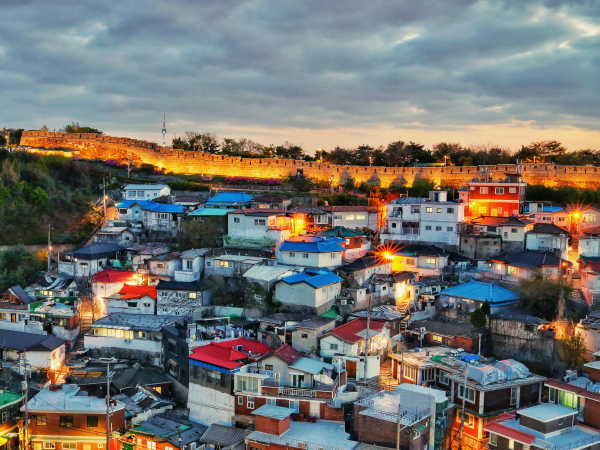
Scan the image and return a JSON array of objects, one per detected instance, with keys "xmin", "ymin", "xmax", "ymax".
[{"xmin": 275, "ymin": 269, "xmax": 342, "ymax": 314}]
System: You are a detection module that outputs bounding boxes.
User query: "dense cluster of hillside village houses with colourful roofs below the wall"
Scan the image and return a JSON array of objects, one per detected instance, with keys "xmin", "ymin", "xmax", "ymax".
[{"xmin": 14, "ymin": 179, "xmax": 600, "ymax": 450}]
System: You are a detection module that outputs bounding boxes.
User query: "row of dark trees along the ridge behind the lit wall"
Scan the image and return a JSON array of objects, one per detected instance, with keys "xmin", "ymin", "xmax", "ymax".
[{"xmin": 173, "ymin": 131, "xmax": 600, "ymax": 167}]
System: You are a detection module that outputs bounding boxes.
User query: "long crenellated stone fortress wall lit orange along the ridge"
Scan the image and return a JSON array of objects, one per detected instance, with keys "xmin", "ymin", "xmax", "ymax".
[{"xmin": 21, "ymin": 131, "xmax": 600, "ymax": 189}]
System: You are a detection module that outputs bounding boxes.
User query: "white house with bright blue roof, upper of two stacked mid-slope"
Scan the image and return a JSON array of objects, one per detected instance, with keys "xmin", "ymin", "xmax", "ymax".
[{"xmin": 277, "ymin": 235, "xmax": 345, "ymax": 269}]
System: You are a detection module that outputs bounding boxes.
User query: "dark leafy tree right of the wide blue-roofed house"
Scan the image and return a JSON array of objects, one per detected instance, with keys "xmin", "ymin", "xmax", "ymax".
[{"xmin": 517, "ymin": 271, "xmax": 573, "ymax": 321}]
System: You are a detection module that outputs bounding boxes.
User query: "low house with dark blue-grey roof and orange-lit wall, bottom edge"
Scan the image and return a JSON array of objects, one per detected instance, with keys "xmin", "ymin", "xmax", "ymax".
[{"xmin": 118, "ymin": 415, "xmax": 208, "ymax": 450}]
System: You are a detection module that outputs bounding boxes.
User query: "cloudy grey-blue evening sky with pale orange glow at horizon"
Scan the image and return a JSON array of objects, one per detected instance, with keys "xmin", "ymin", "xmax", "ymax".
[{"xmin": 0, "ymin": 0, "xmax": 600, "ymax": 153}]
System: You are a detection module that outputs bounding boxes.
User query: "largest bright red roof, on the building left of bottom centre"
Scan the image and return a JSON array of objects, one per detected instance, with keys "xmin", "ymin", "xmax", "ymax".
[{"xmin": 190, "ymin": 338, "xmax": 271, "ymax": 369}]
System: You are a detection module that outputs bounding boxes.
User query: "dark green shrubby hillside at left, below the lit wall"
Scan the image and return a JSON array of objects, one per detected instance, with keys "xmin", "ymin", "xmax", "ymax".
[{"xmin": 0, "ymin": 150, "xmax": 102, "ymax": 245}]
